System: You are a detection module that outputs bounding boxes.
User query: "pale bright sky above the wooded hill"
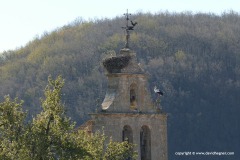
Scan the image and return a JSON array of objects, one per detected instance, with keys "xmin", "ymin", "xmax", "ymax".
[{"xmin": 0, "ymin": 0, "xmax": 240, "ymax": 53}]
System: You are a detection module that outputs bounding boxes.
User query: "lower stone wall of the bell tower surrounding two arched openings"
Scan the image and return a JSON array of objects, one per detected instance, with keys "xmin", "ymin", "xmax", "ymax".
[{"xmin": 92, "ymin": 113, "xmax": 168, "ymax": 160}]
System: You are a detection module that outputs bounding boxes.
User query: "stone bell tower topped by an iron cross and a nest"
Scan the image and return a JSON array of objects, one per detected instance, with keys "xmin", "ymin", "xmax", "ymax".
[{"xmin": 91, "ymin": 10, "xmax": 168, "ymax": 160}]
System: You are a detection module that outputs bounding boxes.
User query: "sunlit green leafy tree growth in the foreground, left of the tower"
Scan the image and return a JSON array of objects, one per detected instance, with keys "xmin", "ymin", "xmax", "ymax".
[{"xmin": 0, "ymin": 76, "xmax": 136, "ymax": 160}]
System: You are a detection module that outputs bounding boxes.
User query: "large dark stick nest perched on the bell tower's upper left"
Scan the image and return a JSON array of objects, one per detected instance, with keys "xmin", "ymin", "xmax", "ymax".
[{"xmin": 103, "ymin": 56, "xmax": 131, "ymax": 73}]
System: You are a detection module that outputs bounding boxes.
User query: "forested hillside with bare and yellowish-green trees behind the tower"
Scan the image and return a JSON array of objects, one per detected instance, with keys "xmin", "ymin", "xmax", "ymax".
[{"xmin": 0, "ymin": 12, "xmax": 240, "ymax": 160}]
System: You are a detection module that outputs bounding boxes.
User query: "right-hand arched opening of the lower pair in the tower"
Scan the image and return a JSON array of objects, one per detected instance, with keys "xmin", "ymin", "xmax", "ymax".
[{"xmin": 140, "ymin": 126, "xmax": 151, "ymax": 160}]
